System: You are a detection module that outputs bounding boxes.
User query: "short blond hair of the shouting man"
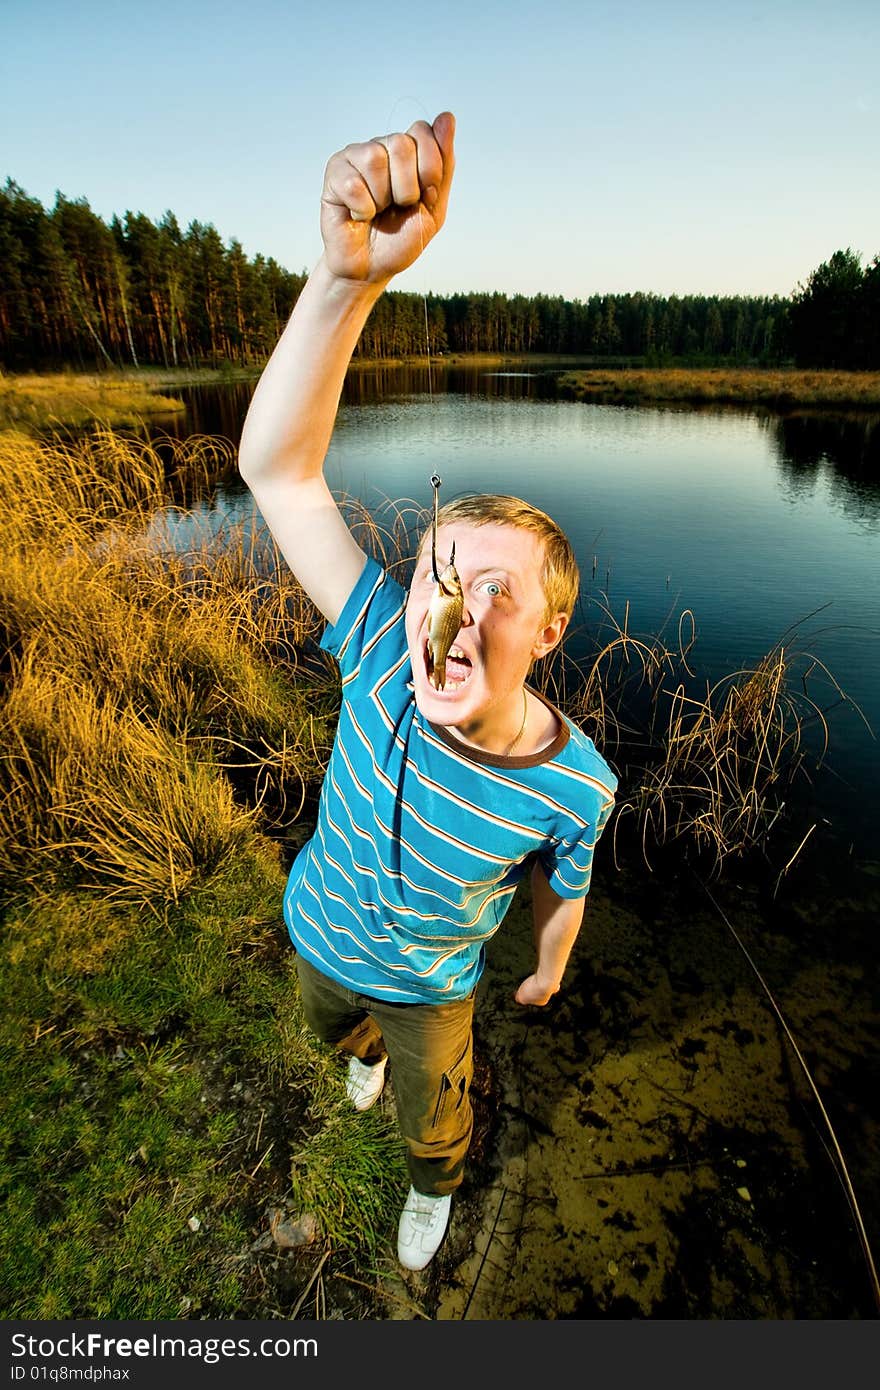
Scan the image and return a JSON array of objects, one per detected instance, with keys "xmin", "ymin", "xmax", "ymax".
[{"xmin": 420, "ymin": 492, "xmax": 581, "ymax": 621}]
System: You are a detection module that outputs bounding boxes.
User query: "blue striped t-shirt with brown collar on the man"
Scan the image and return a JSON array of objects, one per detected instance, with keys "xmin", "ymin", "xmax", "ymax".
[{"xmin": 284, "ymin": 559, "xmax": 617, "ymax": 1004}]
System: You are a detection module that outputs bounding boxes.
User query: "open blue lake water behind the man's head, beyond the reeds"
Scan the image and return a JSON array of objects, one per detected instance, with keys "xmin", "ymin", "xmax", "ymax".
[{"xmin": 166, "ymin": 368, "xmax": 880, "ymax": 858}]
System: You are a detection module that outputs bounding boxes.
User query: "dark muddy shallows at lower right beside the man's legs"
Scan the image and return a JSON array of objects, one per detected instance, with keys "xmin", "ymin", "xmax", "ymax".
[{"xmin": 380, "ymin": 839, "xmax": 880, "ymax": 1321}]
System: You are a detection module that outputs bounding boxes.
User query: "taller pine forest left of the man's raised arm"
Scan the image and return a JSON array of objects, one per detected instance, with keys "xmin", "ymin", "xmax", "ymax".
[{"xmin": 0, "ymin": 179, "xmax": 306, "ymax": 367}]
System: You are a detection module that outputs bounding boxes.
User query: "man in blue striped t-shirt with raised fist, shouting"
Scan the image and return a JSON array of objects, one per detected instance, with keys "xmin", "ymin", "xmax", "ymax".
[{"xmin": 239, "ymin": 113, "xmax": 616, "ymax": 1269}]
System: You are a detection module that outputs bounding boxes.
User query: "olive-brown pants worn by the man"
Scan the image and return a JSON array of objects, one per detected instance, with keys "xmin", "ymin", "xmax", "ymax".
[{"xmin": 296, "ymin": 955, "xmax": 474, "ymax": 1197}]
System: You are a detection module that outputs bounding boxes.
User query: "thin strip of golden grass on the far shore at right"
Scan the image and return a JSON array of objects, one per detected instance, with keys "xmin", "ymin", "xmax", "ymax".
[{"xmin": 559, "ymin": 367, "xmax": 880, "ymax": 410}]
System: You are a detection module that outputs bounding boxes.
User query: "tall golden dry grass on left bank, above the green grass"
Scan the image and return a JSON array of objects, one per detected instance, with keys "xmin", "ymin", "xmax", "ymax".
[{"xmin": 0, "ymin": 431, "xmax": 336, "ymax": 905}]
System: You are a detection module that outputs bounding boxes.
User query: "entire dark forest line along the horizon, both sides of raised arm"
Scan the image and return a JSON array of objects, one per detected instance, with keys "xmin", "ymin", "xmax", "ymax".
[{"xmin": 0, "ymin": 179, "xmax": 880, "ymax": 368}]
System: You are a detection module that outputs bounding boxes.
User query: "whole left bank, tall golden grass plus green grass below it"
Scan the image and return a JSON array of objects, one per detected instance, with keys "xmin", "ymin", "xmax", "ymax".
[{"xmin": 0, "ymin": 431, "xmax": 414, "ymax": 1318}]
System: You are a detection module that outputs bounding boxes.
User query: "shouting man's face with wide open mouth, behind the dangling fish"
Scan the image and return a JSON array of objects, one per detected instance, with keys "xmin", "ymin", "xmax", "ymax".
[{"xmin": 406, "ymin": 521, "xmax": 566, "ymax": 726}]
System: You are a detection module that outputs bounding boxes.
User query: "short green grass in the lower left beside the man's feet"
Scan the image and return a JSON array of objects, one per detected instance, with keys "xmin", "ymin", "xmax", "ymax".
[{"xmin": 0, "ymin": 844, "xmax": 403, "ymax": 1319}]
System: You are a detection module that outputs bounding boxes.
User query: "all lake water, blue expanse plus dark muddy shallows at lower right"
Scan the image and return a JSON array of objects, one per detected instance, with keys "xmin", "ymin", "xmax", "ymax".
[{"xmin": 152, "ymin": 368, "xmax": 880, "ymax": 1321}]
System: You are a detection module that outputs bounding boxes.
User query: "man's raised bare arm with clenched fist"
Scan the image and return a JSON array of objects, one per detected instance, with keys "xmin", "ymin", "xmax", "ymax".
[{"xmin": 239, "ymin": 111, "xmax": 455, "ymax": 623}]
